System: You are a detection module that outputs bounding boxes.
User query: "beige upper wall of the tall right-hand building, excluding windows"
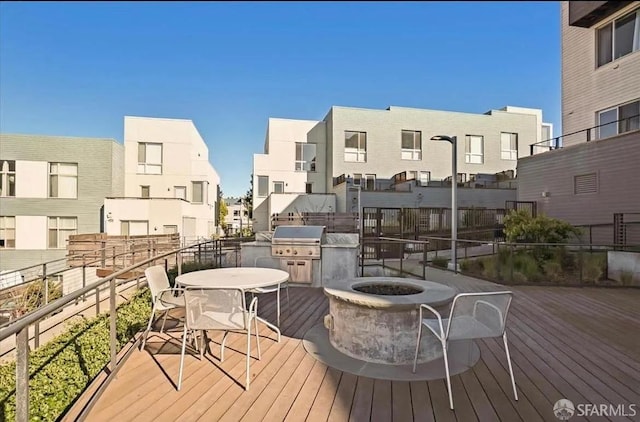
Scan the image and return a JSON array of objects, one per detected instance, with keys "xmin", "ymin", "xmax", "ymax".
[{"xmin": 561, "ymin": 1, "xmax": 640, "ymax": 146}]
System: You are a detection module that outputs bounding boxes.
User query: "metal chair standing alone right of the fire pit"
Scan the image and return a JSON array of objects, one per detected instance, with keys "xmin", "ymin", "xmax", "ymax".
[{"xmin": 413, "ymin": 291, "xmax": 518, "ymax": 410}]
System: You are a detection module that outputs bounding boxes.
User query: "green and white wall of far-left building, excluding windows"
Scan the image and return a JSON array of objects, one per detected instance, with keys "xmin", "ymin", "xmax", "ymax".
[{"xmin": 0, "ymin": 134, "xmax": 124, "ymax": 270}]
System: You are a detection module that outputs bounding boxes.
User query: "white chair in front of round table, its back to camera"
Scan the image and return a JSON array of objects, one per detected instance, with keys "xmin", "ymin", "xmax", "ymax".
[{"xmin": 178, "ymin": 287, "xmax": 261, "ymax": 391}]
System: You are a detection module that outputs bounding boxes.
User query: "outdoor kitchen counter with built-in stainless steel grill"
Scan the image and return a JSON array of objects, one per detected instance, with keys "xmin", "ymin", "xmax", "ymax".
[{"xmin": 241, "ymin": 225, "xmax": 360, "ymax": 287}]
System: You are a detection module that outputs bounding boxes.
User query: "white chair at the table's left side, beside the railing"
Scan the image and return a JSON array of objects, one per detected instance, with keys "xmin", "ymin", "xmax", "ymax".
[{"xmin": 140, "ymin": 265, "xmax": 184, "ymax": 350}]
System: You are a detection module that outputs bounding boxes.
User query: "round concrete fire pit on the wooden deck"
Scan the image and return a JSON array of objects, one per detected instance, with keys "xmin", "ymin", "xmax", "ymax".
[{"xmin": 324, "ymin": 277, "xmax": 456, "ymax": 365}]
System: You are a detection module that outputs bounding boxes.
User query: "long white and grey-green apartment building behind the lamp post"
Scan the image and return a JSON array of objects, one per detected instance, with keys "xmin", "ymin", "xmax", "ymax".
[{"xmin": 253, "ymin": 106, "xmax": 553, "ymax": 230}]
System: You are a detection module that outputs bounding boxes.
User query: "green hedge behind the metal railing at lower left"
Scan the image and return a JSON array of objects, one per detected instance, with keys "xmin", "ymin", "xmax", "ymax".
[{"xmin": 0, "ymin": 288, "xmax": 151, "ymax": 421}]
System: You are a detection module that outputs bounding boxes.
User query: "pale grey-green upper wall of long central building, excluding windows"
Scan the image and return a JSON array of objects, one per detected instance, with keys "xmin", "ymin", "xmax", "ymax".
[{"xmin": 327, "ymin": 107, "xmax": 541, "ymax": 180}]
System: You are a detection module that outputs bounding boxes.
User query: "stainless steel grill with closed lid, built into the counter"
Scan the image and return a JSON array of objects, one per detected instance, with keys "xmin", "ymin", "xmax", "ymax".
[{"xmin": 271, "ymin": 226, "xmax": 326, "ymax": 283}]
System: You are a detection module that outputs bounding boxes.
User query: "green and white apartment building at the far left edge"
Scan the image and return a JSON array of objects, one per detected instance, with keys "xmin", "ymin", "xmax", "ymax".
[{"xmin": 0, "ymin": 134, "xmax": 124, "ymax": 270}]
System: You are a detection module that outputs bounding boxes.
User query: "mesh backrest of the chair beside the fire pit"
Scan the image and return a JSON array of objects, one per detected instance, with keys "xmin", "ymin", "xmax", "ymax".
[{"xmin": 446, "ymin": 291, "xmax": 513, "ymax": 340}]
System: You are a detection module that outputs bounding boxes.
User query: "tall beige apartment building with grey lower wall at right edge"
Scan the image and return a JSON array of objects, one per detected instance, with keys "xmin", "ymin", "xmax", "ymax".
[{"xmin": 518, "ymin": 1, "xmax": 640, "ymax": 234}]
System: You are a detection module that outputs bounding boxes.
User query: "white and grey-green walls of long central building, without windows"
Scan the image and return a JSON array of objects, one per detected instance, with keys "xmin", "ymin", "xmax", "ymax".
[{"xmin": 253, "ymin": 106, "xmax": 548, "ymax": 230}]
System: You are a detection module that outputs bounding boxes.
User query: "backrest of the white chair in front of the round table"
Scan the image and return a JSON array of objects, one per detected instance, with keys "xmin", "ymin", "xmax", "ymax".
[{"xmin": 184, "ymin": 287, "xmax": 249, "ymax": 330}]
